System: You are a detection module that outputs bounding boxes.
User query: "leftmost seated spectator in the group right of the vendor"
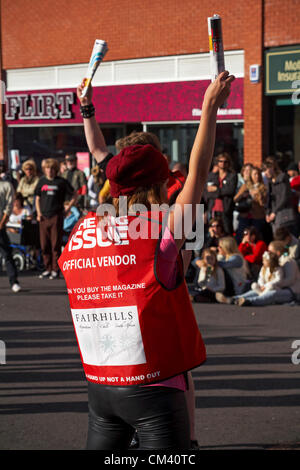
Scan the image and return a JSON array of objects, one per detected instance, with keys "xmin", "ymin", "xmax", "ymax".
[{"xmin": 190, "ymin": 248, "xmax": 225, "ymax": 302}]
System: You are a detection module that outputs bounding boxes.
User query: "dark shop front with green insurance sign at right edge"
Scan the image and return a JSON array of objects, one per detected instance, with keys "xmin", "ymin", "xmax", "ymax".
[{"xmin": 265, "ymin": 45, "xmax": 300, "ymax": 169}]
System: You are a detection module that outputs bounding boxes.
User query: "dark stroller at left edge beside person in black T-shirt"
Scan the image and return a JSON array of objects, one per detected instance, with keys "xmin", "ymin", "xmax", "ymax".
[{"xmin": 2, "ymin": 220, "xmax": 42, "ymax": 271}]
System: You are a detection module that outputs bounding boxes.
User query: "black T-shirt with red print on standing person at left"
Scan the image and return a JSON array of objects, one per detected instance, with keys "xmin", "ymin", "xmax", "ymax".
[{"xmin": 35, "ymin": 176, "xmax": 74, "ymax": 218}]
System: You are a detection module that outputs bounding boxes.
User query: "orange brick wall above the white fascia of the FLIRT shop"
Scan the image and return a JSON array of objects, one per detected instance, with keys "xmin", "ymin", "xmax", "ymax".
[{"xmin": 2, "ymin": 0, "xmax": 251, "ymax": 69}]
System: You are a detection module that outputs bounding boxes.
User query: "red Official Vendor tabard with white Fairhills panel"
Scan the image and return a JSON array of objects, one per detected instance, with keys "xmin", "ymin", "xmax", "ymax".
[{"xmin": 59, "ymin": 213, "xmax": 206, "ymax": 386}]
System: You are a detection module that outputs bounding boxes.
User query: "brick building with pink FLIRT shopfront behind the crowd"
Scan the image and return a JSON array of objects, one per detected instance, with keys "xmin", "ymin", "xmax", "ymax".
[{"xmin": 0, "ymin": 0, "xmax": 300, "ymax": 173}]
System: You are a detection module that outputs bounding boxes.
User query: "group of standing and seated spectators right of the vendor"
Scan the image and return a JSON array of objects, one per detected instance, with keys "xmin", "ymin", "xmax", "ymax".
[{"xmin": 190, "ymin": 153, "xmax": 300, "ymax": 306}]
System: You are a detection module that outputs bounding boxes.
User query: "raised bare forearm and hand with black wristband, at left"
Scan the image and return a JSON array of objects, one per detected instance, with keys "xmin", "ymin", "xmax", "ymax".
[{"xmin": 77, "ymin": 82, "xmax": 109, "ymax": 163}]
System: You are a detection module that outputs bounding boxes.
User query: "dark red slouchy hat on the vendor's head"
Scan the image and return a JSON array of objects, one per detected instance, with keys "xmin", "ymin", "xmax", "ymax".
[{"xmin": 106, "ymin": 144, "xmax": 169, "ymax": 197}]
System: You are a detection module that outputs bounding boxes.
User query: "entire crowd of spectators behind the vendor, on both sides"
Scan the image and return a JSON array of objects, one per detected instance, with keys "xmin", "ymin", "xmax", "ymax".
[{"xmin": 0, "ymin": 132, "xmax": 300, "ymax": 305}]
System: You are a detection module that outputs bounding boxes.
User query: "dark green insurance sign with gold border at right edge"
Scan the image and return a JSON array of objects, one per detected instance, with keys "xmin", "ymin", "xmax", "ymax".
[{"xmin": 265, "ymin": 45, "xmax": 300, "ymax": 95}]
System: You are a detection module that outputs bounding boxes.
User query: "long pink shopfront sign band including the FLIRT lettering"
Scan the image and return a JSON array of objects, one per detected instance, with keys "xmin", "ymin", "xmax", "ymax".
[{"xmin": 6, "ymin": 78, "xmax": 244, "ymax": 126}]
